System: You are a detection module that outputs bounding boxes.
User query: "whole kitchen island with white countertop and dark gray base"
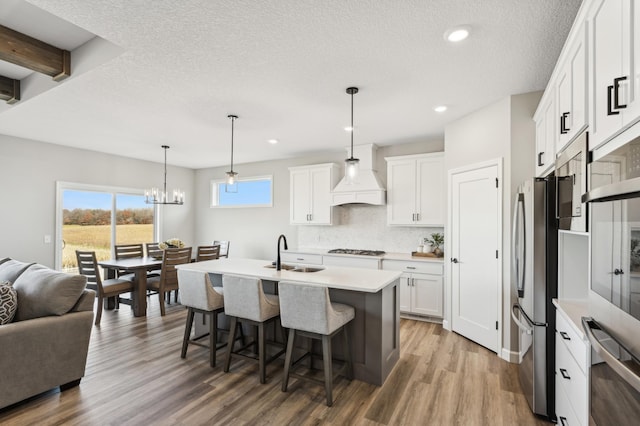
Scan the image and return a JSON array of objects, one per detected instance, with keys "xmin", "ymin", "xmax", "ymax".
[{"xmin": 177, "ymin": 258, "xmax": 401, "ymax": 386}]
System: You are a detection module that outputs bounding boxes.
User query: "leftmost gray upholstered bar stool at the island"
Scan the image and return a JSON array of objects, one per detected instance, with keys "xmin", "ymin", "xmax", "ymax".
[{"xmin": 178, "ymin": 269, "xmax": 238, "ymax": 367}]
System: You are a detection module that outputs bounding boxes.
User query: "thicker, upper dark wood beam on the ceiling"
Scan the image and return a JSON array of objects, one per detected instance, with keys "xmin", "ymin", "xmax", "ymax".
[{"xmin": 0, "ymin": 25, "xmax": 71, "ymax": 81}]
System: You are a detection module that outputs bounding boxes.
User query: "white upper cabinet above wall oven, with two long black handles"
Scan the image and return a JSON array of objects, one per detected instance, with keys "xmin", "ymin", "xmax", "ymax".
[{"xmin": 588, "ymin": 0, "xmax": 640, "ymax": 149}]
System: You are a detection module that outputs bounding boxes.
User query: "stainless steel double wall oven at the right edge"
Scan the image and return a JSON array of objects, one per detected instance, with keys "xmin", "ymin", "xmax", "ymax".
[{"xmin": 582, "ymin": 138, "xmax": 640, "ymax": 426}]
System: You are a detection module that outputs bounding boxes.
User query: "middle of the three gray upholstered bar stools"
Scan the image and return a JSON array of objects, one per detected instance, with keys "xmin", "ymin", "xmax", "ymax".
[{"xmin": 222, "ymin": 275, "xmax": 285, "ymax": 383}]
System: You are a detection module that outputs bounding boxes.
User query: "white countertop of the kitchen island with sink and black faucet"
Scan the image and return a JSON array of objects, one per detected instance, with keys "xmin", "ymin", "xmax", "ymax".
[{"xmin": 176, "ymin": 252, "xmax": 402, "ymax": 293}]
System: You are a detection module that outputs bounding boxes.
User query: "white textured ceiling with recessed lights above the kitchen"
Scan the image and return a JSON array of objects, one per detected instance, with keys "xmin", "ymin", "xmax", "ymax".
[{"xmin": 0, "ymin": 0, "xmax": 580, "ymax": 168}]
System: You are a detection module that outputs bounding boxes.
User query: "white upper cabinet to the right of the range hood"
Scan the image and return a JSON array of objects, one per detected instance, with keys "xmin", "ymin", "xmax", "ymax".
[{"xmin": 385, "ymin": 152, "xmax": 446, "ymax": 226}]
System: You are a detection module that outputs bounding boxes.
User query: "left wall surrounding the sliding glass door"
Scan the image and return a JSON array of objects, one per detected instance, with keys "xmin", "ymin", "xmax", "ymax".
[{"xmin": 0, "ymin": 135, "xmax": 196, "ymax": 267}]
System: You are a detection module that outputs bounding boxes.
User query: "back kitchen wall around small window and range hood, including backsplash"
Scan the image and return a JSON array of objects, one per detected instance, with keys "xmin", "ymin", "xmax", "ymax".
[{"xmin": 195, "ymin": 140, "xmax": 443, "ymax": 259}]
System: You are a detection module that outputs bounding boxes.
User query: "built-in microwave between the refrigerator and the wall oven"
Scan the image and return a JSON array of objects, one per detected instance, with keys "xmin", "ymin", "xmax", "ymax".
[{"xmin": 555, "ymin": 132, "xmax": 588, "ymax": 232}]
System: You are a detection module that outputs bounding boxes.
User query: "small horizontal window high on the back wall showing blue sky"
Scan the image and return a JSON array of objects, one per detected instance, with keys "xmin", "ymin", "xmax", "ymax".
[{"xmin": 211, "ymin": 176, "xmax": 273, "ymax": 207}]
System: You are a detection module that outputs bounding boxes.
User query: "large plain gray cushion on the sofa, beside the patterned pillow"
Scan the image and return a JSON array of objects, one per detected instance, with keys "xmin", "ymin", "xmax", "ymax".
[{"xmin": 13, "ymin": 265, "xmax": 87, "ymax": 321}]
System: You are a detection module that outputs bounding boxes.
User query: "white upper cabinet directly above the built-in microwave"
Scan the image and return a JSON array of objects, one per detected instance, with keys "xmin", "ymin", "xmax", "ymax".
[{"xmin": 555, "ymin": 22, "xmax": 587, "ymax": 152}]
